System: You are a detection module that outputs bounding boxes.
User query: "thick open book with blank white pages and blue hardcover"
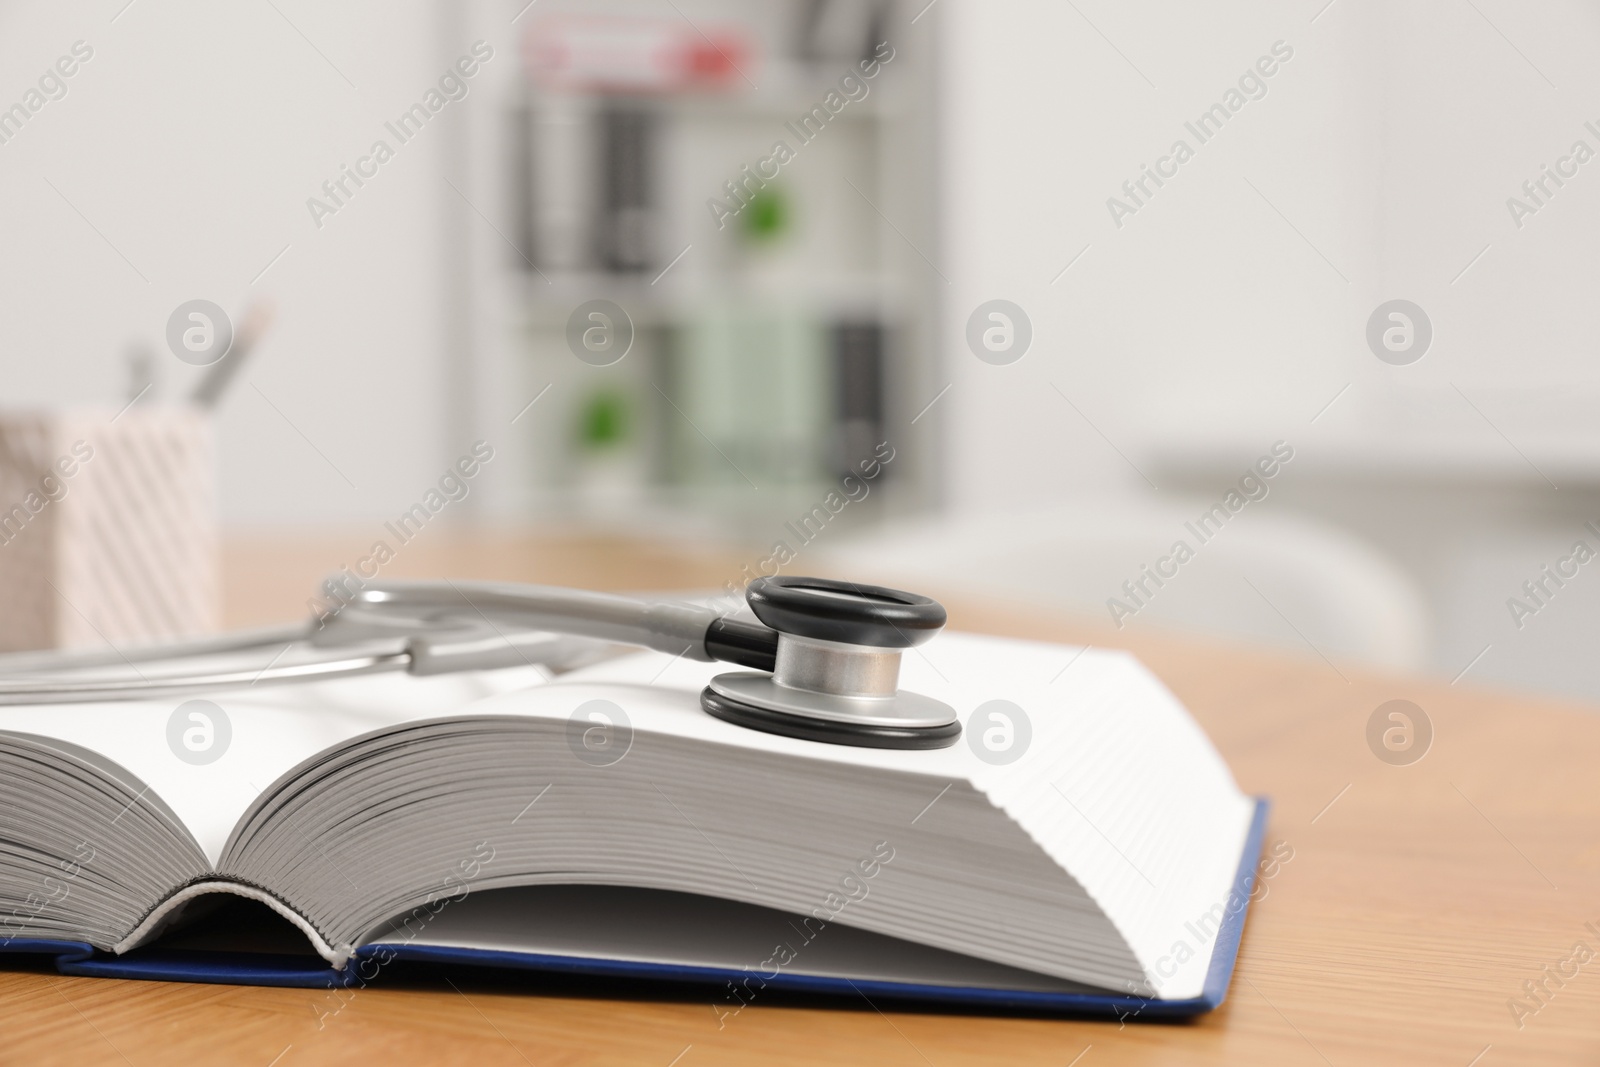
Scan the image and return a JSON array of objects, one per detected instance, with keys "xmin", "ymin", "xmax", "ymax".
[{"xmin": 0, "ymin": 633, "xmax": 1264, "ymax": 1016}]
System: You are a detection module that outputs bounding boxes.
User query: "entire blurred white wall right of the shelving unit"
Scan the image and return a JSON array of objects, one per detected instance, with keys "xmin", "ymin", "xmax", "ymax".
[{"xmin": 938, "ymin": 0, "xmax": 1600, "ymax": 502}]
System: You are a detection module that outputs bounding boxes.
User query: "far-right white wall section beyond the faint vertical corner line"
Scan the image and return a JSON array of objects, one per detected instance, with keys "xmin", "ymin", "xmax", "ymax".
[{"xmin": 1381, "ymin": 0, "xmax": 1600, "ymax": 406}]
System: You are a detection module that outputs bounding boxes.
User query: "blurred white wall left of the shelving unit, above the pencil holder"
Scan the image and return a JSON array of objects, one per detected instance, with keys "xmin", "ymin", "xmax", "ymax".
[{"xmin": 0, "ymin": 0, "xmax": 480, "ymax": 523}]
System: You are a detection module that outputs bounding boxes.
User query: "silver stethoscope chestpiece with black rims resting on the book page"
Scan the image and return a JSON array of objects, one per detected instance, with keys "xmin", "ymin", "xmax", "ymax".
[{"xmin": 701, "ymin": 576, "xmax": 962, "ymax": 749}]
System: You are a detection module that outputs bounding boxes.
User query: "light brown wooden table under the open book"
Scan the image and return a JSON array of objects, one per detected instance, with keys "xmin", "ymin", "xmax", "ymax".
[{"xmin": 0, "ymin": 531, "xmax": 1600, "ymax": 1067}]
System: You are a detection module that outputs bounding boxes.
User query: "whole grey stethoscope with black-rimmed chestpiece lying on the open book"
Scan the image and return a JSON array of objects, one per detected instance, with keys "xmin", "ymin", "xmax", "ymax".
[{"xmin": 0, "ymin": 576, "xmax": 962, "ymax": 749}]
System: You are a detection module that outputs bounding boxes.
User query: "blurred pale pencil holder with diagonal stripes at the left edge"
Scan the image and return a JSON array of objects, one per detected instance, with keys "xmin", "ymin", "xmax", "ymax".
[{"xmin": 0, "ymin": 406, "xmax": 221, "ymax": 651}]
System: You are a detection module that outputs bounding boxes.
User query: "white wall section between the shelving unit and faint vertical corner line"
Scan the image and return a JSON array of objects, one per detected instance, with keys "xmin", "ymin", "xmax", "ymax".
[{"xmin": 939, "ymin": 0, "xmax": 1381, "ymax": 507}]
